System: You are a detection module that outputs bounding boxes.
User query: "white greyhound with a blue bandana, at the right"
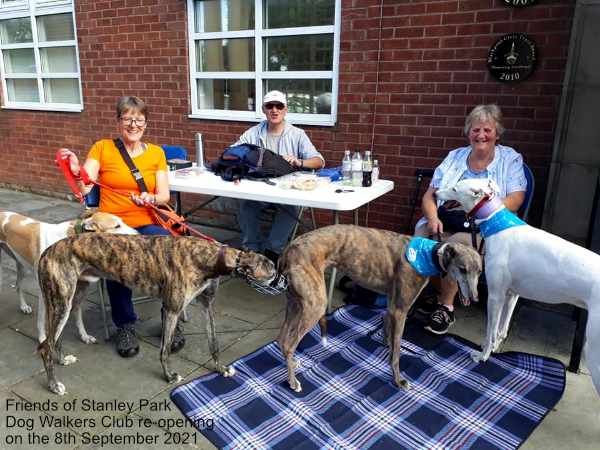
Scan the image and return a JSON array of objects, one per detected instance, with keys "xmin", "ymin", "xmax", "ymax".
[{"xmin": 436, "ymin": 179, "xmax": 600, "ymax": 395}]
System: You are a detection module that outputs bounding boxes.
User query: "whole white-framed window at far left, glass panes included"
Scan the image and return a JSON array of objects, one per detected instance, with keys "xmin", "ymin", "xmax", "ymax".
[{"xmin": 0, "ymin": 0, "xmax": 83, "ymax": 111}]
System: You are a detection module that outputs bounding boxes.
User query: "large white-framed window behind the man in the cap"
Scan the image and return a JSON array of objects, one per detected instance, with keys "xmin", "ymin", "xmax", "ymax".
[{"xmin": 188, "ymin": 0, "xmax": 341, "ymax": 125}]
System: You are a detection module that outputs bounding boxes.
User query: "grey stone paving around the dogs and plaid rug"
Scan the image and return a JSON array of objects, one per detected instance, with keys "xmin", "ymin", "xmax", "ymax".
[{"xmin": 0, "ymin": 189, "xmax": 600, "ymax": 450}]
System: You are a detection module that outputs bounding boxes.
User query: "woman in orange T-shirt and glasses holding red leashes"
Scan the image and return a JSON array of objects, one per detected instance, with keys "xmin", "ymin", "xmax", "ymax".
[{"xmin": 63, "ymin": 96, "xmax": 185, "ymax": 358}]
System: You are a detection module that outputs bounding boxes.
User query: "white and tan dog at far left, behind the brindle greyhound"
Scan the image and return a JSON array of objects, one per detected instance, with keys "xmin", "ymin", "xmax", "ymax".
[{"xmin": 0, "ymin": 211, "xmax": 138, "ymax": 344}]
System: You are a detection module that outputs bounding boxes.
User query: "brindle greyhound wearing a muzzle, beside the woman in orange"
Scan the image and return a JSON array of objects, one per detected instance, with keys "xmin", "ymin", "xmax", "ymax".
[{"xmin": 38, "ymin": 234, "xmax": 277, "ymax": 395}]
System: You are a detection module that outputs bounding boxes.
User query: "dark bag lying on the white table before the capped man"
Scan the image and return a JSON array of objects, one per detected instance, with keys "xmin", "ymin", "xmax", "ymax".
[{"xmin": 211, "ymin": 144, "xmax": 296, "ymax": 181}]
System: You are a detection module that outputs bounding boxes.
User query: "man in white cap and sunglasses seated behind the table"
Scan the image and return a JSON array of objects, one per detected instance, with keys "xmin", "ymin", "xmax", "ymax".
[{"xmin": 235, "ymin": 91, "xmax": 325, "ymax": 261}]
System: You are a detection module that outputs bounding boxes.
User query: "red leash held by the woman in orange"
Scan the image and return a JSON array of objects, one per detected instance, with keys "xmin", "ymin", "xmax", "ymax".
[{"xmin": 55, "ymin": 150, "xmax": 217, "ymax": 242}]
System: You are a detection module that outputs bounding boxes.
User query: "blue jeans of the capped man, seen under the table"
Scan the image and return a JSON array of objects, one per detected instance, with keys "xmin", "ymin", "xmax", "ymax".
[{"xmin": 238, "ymin": 200, "xmax": 300, "ymax": 254}]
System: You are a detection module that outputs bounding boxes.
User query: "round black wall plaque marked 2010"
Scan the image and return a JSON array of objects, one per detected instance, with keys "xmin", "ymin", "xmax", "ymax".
[{"xmin": 488, "ymin": 33, "xmax": 537, "ymax": 83}]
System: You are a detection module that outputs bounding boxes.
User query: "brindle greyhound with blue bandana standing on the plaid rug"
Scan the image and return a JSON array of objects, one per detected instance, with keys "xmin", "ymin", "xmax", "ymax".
[{"xmin": 278, "ymin": 225, "xmax": 481, "ymax": 392}]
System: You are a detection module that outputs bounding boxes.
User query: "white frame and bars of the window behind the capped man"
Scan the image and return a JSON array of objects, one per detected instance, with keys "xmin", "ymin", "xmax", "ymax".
[{"xmin": 187, "ymin": 0, "xmax": 342, "ymax": 126}]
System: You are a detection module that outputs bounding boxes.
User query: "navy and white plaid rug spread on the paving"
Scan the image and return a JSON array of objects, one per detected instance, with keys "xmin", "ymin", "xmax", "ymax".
[{"xmin": 171, "ymin": 306, "xmax": 565, "ymax": 450}]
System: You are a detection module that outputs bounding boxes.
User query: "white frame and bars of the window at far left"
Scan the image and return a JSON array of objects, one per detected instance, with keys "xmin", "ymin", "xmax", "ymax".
[{"xmin": 0, "ymin": 0, "xmax": 83, "ymax": 112}]
